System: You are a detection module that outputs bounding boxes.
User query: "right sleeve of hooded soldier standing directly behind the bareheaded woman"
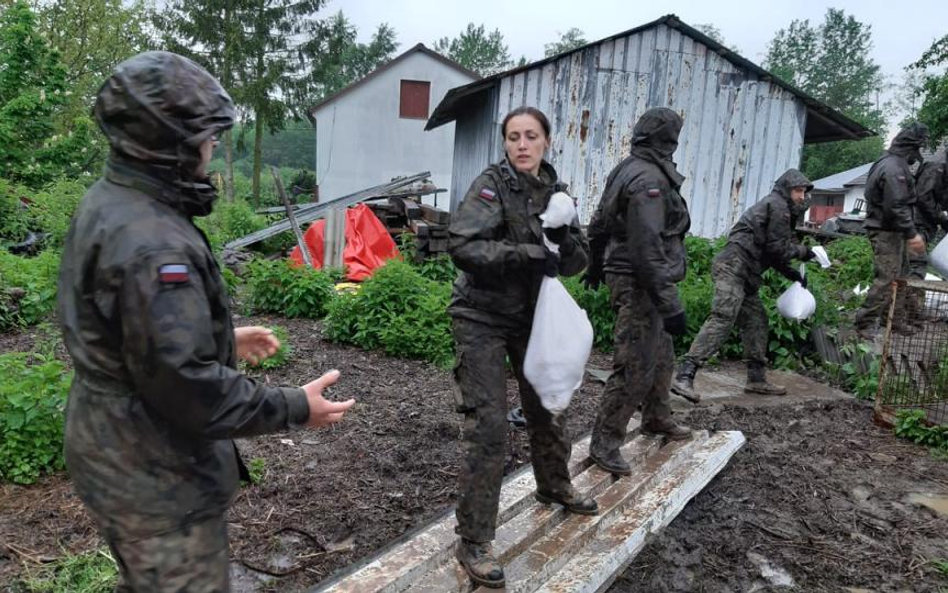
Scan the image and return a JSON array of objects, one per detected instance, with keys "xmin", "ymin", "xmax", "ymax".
[{"xmin": 626, "ymin": 182, "xmax": 684, "ymax": 317}]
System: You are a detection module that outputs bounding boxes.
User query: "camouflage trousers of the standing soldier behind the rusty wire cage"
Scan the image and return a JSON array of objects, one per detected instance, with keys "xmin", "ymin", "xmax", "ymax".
[{"xmin": 856, "ymin": 230, "xmax": 912, "ymax": 329}]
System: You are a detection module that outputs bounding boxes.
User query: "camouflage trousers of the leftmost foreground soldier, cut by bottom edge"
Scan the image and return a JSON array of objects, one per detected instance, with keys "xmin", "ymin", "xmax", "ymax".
[{"xmin": 108, "ymin": 516, "xmax": 230, "ymax": 593}]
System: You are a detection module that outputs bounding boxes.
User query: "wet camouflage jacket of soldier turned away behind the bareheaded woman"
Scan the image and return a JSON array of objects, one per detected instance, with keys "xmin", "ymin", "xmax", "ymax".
[{"xmin": 589, "ymin": 153, "xmax": 691, "ymax": 317}]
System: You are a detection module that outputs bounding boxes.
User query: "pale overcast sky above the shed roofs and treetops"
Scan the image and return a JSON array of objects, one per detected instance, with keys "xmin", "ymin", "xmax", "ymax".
[{"xmin": 323, "ymin": 0, "xmax": 948, "ymax": 134}]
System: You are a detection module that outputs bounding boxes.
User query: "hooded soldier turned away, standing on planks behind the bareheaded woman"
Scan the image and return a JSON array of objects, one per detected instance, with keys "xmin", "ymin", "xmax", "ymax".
[{"xmin": 586, "ymin": 107, "xmax": 691, "ymax": 475}]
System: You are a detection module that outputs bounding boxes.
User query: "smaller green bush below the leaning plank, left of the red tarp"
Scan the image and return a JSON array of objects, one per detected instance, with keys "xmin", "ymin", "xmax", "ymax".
[{"xmin": 247, "ymin": 259, "xmax": 335, "ymax": 319}]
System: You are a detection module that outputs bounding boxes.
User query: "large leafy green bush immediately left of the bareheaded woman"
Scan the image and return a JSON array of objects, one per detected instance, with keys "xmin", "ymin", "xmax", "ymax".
[{"xmin": 324, "ymin": 260, "xmax": 454, "ymax": 366}]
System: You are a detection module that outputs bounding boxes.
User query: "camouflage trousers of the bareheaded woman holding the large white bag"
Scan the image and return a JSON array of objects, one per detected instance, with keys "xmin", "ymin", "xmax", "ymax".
[{"xmin": 454, "ymin": 318, "xmax": 571, "ymax": 543}]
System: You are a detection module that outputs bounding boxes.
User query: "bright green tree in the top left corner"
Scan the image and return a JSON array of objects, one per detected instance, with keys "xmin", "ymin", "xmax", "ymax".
[{"xmin": 0, "ymin": 0, "xmax": 94, "ymax": 187}]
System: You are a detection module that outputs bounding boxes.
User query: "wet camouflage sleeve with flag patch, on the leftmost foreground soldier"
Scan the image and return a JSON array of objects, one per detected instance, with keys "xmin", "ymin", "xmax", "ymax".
[{"xmin": 120, "ymin": 251, "xmax": 309, "ymax": 439}]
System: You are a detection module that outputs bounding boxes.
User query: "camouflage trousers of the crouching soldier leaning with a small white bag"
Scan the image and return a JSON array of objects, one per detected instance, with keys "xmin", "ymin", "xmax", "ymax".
[{"xmin": 684, "ymin": 256, "xmax": 768, "ymax": 367}]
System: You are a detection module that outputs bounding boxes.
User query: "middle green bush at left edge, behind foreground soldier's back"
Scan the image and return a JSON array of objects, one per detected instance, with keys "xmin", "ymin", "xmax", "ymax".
[{"xmin": 0, "ymin": 250, "xmax": 59, "ymax": 331}]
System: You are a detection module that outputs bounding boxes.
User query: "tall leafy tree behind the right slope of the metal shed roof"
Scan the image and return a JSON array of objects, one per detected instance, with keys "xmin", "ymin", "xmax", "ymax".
[{"xmin": 765, "ymin": 8, "xmax": 886, "ymax": 179}]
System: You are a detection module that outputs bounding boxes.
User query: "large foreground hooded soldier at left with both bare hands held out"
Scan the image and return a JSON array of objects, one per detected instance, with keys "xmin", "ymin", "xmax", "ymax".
[{"xmin": 58, "ymin": 52, "xmax": 352, "ymax": 592}]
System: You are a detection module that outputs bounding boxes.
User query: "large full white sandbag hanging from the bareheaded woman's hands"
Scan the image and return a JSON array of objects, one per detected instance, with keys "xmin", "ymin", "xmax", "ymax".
[{"xmin": 523, "ymin": 276, "xmax": 593, "ymax": 414}]
